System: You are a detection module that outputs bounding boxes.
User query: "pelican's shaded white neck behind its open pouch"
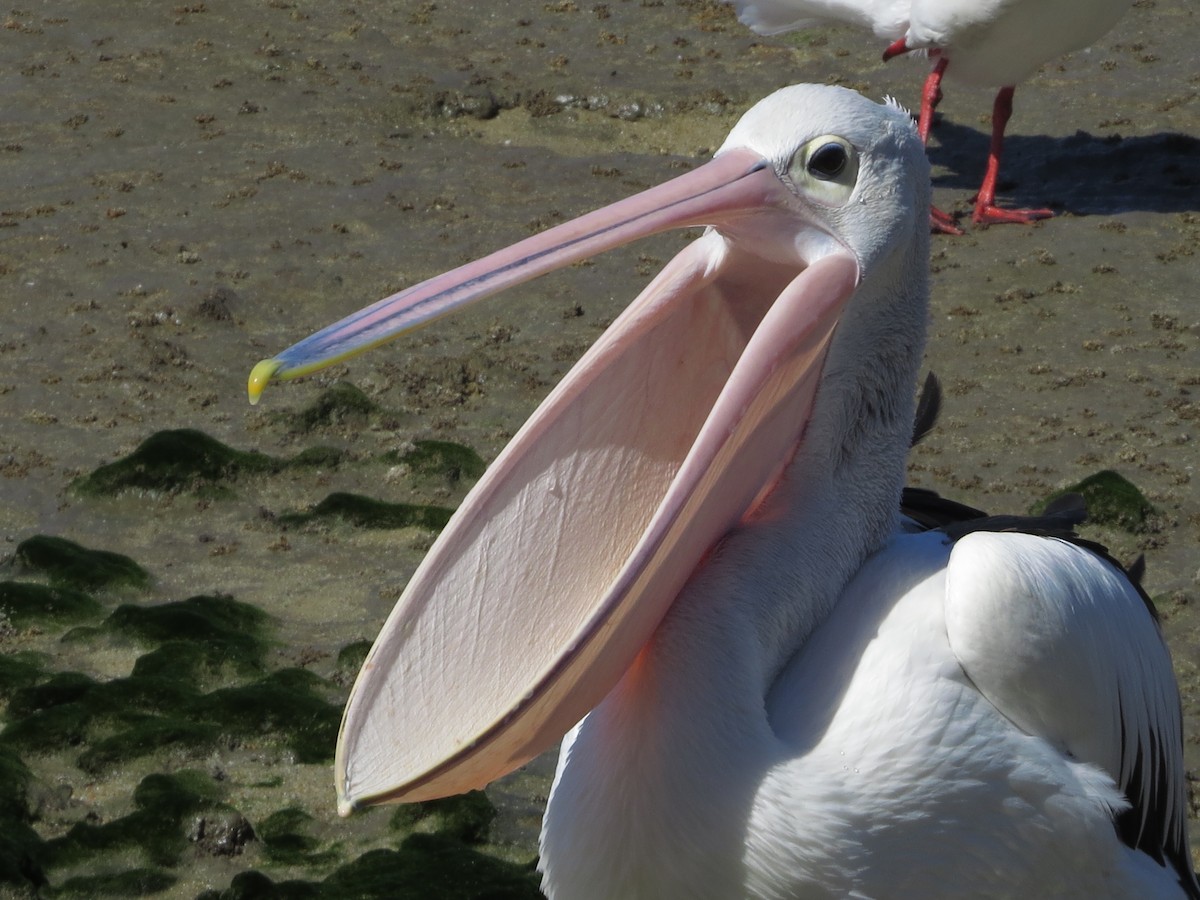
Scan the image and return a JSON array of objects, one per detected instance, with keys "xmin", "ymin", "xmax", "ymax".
[{"xmin": 542, "ymin": 233, "xmax": 929, "ymax": 900}]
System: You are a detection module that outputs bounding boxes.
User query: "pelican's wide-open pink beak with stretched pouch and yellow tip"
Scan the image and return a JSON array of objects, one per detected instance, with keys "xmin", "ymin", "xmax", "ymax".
[{"xmin": 251, "ymin": 149, "xmax": 858, "ymax": 814}]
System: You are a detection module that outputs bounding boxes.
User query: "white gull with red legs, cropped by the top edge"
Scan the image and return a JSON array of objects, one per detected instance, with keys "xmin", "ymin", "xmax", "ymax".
[{"xmin": 730, "ymin": 0, "xmax": 1129, "ymax": 234}]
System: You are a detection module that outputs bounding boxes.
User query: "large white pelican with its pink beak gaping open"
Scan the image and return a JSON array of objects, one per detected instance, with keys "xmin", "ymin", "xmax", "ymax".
[{"xmin": 250, "ymin": 85, "xmax": 1200, "ymax": 900}]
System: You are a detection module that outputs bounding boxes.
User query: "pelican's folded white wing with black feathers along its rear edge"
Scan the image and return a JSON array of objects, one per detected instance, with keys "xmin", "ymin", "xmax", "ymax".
[{"xmin": 946, "ymin": 532, "xmax": 1200, "ymax": 896}]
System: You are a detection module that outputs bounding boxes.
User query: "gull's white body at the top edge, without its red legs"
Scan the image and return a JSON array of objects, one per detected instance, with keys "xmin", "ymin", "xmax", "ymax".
[{"xmin": 732, "ymin": 0, "xmax": 1129, "ymax": 88}]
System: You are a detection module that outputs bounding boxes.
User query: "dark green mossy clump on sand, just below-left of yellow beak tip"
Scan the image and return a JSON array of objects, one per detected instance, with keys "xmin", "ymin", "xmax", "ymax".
[{"xmin": 71, "ymin": 428, "xmax": 284, "ymax": 497}]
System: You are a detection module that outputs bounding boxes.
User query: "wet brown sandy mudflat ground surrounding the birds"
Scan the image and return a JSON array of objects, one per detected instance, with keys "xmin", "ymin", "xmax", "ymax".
[{"xmin": 0, "ymin": 0, "xmax": 1200, "ymax": 898}]
